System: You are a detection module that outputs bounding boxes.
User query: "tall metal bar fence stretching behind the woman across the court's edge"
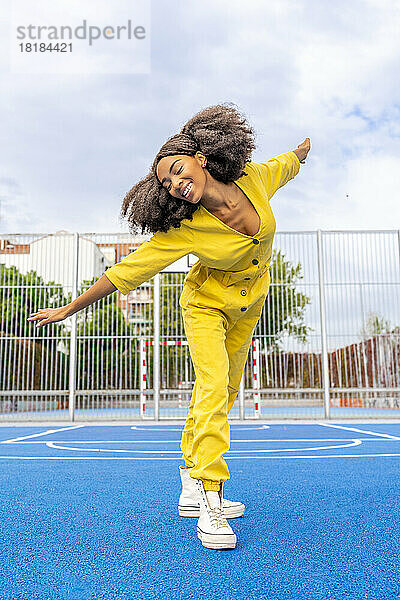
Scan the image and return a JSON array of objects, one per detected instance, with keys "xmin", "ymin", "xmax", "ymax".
[{"xmin": 0, "ymin": 230, "xmax": 400, "ymax": 421}]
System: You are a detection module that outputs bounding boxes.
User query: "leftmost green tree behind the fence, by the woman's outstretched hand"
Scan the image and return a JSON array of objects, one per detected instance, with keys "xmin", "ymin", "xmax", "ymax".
[{"xmin": 0, "ymin": 265, "xmax": 68, "ymax": 411}]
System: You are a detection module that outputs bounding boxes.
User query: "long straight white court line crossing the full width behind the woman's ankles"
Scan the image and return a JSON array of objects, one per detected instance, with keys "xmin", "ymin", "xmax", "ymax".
[{"xmin": 0, "ymin": 454, "xmax": 400, "ymax": 462}]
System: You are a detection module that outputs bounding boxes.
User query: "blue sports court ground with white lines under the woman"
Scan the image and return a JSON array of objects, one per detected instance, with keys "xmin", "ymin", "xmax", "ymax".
[{"xmin": 0, "ymin": 422, "xmax": 400, "ymax": 600}]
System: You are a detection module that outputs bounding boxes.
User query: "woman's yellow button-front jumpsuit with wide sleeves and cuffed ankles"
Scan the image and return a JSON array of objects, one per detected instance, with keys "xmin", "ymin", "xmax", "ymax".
[{"xmin": 105, "ymin": 150, "xmax": 300, "ymax": 490}]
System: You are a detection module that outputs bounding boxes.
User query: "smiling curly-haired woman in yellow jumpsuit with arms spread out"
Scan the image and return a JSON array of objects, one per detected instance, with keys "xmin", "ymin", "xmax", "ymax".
[{"xmin": 30, "ymin": 103, "xmax": 310, "ymax": 549}]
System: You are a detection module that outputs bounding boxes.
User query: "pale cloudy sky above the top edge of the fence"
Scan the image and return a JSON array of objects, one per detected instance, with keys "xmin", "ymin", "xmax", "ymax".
[{"xmin": 0, "ymin": 0, "xmax": 400, "ymax": 234}]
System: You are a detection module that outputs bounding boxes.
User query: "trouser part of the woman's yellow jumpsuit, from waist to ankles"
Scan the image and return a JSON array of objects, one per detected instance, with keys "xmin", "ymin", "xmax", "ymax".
[{"xmin": 181, "ymin": 264, "xmax": 269, "ymax": 490}]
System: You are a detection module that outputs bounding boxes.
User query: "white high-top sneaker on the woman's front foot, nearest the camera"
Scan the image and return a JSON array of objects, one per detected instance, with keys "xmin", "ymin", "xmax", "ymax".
[{"xmin": 195, "ymin": 479, "xmax": 236, "ymax": 550}]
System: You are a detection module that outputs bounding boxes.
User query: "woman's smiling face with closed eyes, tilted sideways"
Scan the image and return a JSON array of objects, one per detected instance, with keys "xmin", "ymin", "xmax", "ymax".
[{"xmin": 156, "ymin": 152, "xmax": 206, "ymax": 204}]
